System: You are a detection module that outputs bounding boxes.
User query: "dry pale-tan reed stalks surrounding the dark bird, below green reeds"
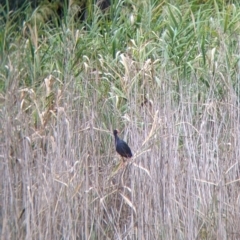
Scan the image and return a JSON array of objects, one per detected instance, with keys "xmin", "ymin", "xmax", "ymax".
[{"xmin": 0, "ymin": 55, "xmax": 240, "ymax": 239}]
